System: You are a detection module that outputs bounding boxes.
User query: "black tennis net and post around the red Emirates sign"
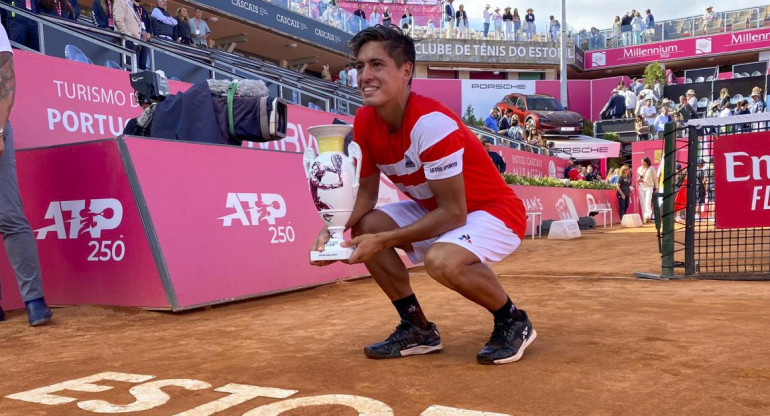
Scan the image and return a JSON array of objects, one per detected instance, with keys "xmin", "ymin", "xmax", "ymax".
[{"xmin": 639, "ymin": 113, "xmax": 770, "ymax": 280}]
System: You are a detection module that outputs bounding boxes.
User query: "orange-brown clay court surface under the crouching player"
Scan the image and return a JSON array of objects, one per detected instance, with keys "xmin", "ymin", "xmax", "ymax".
[{"xmin": 0, "ymin": 225, "xmax": 770, "ymax": 416}]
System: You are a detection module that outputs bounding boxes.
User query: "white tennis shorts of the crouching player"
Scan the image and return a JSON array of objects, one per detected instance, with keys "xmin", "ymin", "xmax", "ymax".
[{"xmin": 377, "ymin": 200, "xmax": 521, "ymax": 264}]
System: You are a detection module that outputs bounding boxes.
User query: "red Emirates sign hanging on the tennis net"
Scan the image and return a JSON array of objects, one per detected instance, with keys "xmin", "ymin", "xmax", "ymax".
[{"xmin": 714, "ymin": 132, "xmax": 770, "ymax": 228}]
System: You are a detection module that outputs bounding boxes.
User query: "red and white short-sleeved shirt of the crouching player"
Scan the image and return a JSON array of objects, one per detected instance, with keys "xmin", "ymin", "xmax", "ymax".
[{"xmin": 353, "ymin": 92, "xmax": 527, "ymax": 238}]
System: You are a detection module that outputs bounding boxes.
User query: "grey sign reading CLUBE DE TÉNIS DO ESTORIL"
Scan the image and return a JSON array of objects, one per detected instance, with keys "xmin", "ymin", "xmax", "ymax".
[{"xmin": 415, "ymin": 38, "xmax": 575, "ymax": 65}]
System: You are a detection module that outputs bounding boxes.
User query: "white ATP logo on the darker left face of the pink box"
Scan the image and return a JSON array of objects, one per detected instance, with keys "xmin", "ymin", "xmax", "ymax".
[{"xmin": 35, "ymin": 198, "xmax": 123, "ymax": 240}]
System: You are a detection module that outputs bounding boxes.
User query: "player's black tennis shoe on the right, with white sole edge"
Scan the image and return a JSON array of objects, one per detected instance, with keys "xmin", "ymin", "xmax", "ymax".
[{"xmin": 476, "ymin": 309, "xmax": 537, "ymax": 364}]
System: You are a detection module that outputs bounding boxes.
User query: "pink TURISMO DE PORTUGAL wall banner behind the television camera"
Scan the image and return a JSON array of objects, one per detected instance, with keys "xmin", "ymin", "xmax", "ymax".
[{"xmin": 11, "ymin": 50, "xmax": 189, "ymax": 149}]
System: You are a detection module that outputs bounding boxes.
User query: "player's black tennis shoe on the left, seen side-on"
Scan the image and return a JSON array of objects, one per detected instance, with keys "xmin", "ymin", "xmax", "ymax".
[{"xmin": 364, "ymin": 320, "xmax": 444, "ymax": 359}]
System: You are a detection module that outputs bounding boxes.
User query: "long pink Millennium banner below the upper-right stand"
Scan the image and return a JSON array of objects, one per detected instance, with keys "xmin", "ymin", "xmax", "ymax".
[{"xmin": 585, "ymin": 28, "xmax": 770, "ymax": 69}]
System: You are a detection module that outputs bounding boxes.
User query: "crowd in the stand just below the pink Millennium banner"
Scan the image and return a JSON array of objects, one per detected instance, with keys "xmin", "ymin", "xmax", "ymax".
[{"xmin": 601, "ymin": 79, "xmax": 765, "ymax": 140}]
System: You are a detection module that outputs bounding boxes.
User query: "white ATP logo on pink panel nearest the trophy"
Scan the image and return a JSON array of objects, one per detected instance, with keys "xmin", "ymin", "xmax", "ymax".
[{"xmin": 217, "ymin": 192, "xmax": 286, "ymax": 227}]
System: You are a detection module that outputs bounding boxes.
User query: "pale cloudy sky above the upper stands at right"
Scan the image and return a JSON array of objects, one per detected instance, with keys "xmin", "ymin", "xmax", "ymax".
[{"xmin": 455, "ymin": 0, "xmax": 770, "ymax": 32}]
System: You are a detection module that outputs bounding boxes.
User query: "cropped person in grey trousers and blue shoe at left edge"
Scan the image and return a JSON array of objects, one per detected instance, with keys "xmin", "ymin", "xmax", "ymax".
[{"xmin": 0, "ymin": 24, "xmax": 53, "ymax": 326}]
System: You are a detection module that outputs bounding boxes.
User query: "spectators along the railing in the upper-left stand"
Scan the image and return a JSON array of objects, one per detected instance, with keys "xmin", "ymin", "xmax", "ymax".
[{"xmin": 0, "ymin": 0, "xmax": 211, "ymax": 69}]
